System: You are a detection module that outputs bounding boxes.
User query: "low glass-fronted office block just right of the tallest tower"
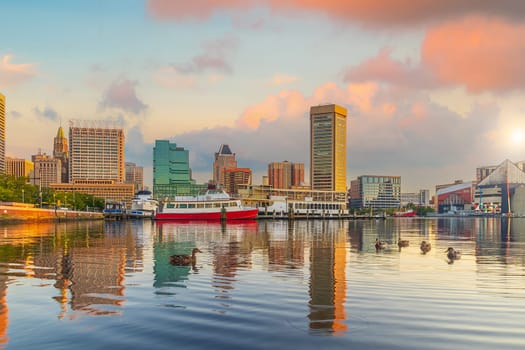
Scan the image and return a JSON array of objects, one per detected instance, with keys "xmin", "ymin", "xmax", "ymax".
[{"xmin": 350, "ymin": 175, "xmax": 401, "ymax": 209}]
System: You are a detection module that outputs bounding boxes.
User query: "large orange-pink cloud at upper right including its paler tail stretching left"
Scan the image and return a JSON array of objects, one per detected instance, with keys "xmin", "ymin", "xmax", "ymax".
[{"xmin": 343, "ymin": 17, "xmax": 525, "ymax": 93}]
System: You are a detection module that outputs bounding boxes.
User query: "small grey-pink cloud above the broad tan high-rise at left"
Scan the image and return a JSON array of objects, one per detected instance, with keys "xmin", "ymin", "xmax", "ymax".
[{"xmin": 100, "ymin": 78, "xmax": 148, "ymax": 114}]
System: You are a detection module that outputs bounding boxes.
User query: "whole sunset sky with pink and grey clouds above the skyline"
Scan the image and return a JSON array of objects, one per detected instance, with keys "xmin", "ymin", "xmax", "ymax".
[{"xmin": 0, "ymin": 0, "xmax": 525, "ymax": 192}]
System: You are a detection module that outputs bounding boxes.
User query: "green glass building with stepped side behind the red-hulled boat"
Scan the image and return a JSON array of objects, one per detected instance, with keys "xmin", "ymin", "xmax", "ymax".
[{"xmin": 153, "ymin": 140, "xmax": 207, "ymax": 199}]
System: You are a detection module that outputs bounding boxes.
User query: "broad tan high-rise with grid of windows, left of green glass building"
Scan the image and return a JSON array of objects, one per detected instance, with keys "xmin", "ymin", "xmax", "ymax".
[{"xmin": 69, "ymin": 120, "xmax": 126, "ymax": 183}]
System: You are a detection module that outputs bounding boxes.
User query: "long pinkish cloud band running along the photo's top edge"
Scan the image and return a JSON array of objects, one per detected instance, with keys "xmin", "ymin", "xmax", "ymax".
[{"xmin": 146, "ymin": 0, "xmax": 525, "ymax": 27}]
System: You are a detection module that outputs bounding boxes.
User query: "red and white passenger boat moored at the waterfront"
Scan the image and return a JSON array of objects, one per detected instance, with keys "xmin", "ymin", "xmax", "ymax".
[{"xmin": 155, "ymin": 190, "xmax": 259, "ymax": 220}]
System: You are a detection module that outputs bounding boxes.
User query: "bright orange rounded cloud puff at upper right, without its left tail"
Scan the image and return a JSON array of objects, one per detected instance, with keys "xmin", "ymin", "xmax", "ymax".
[{"xmin": 421, "ymin": 15, "xmax": 525, "ymax": 92}]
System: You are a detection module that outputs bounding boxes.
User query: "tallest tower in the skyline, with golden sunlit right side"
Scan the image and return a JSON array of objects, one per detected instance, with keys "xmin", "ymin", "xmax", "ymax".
[{"xmin": 310, "ymin": 104, "xmax": 347, "ymax": 192}]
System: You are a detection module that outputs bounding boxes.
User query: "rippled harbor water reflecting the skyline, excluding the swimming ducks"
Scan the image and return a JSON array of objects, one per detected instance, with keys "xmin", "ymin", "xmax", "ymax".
[{"xmin": 0, "ymin": 217, "xmax": 525, "ymax": 350}]
